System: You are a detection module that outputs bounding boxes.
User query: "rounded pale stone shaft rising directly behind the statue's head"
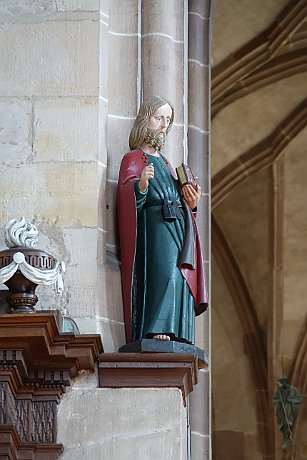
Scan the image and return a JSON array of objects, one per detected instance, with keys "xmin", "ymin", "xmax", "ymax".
[{"xmin": 142, "ymin": 0, "xmax": 188, "ymax": 166}]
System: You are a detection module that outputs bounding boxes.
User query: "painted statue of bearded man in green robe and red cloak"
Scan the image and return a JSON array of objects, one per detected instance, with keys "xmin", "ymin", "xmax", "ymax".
[{"xmin": 118, "ymin": 96, "xmax": 207, "ymax": 343}]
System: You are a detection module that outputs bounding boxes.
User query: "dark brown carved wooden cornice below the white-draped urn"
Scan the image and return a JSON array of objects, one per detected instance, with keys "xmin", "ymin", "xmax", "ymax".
[{"xmin": 0, "ymin": 312, "xmax": 103, "ymax": 460}]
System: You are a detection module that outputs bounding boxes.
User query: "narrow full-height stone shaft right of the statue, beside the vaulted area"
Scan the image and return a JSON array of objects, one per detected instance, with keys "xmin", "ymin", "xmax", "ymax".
[{"xmin": 188, "ymin": 0, "xmax": 214, "ymax": 460}]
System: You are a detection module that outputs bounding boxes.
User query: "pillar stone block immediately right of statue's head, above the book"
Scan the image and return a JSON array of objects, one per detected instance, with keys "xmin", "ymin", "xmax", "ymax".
[{"xmin": 188, "ymin": 126, "xmax": 210, "ymax": 193}]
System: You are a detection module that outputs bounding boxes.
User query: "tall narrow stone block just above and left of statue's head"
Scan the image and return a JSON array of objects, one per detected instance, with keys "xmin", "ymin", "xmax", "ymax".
[{"xmin": 108, "ymin": 35, "xmax": 138, "ymax": 118}]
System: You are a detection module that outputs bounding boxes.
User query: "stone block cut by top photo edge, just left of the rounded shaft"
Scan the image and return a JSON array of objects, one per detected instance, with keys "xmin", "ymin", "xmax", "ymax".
[{"xmin": 109, "ymin": 0, "xmax": 139, "ymax": 34}]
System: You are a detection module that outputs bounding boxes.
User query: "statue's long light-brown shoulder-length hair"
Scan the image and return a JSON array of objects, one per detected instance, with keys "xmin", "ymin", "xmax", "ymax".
[{"xmin": 129, "ymin": 96, "xmax": 174, "ymax": 150}]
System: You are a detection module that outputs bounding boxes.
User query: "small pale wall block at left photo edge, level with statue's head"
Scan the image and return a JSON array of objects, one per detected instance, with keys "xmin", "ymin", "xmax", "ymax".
[{"xmin": 0, "ymin": 98, "xmax": 32, "ymax": 164}]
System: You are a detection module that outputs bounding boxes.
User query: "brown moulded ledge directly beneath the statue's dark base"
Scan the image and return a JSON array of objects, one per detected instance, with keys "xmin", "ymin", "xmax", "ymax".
[{"xmin": 99, "ymin": 353, "xmax": 198, "ymax": 404}]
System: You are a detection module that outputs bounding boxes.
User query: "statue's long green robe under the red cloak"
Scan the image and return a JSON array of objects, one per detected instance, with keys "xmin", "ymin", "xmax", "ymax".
[{"xmin": 132, "ymin": 155, "xmax": 195, "ymax": 343}]
